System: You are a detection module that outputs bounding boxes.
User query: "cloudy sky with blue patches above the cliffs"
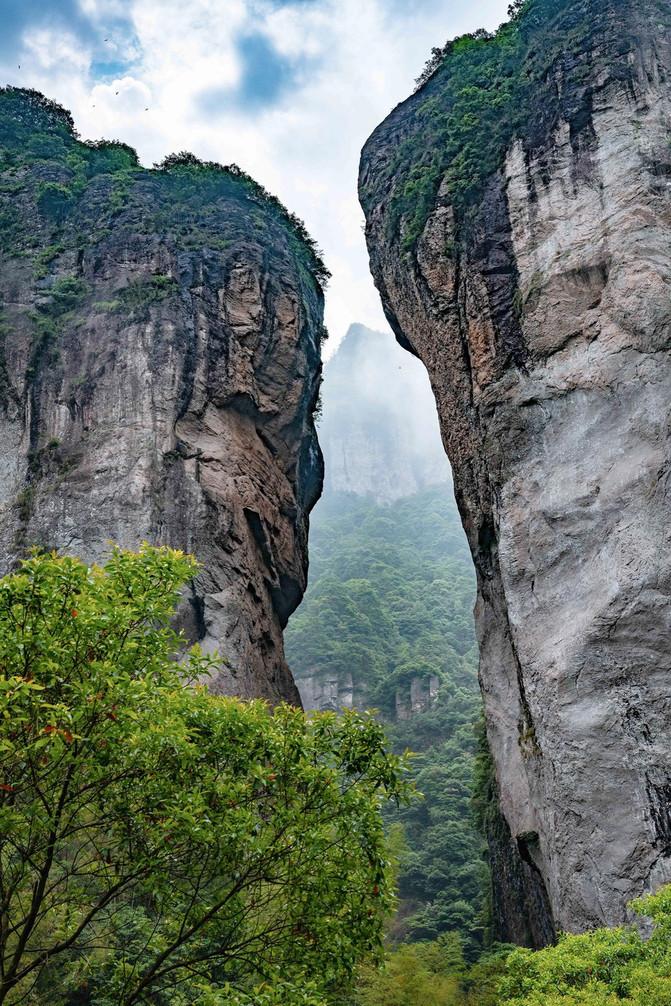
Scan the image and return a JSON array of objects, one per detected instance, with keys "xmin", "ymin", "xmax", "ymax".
[{"xmin": 0, "ymin": 0, "xmax": 509, "ymax": 355}]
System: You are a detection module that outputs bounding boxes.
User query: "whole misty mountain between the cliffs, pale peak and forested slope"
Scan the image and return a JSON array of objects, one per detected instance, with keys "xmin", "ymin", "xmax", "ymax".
[{"xmin": 285, "ymin": 325, "xmax": 489, "ymax": 957}]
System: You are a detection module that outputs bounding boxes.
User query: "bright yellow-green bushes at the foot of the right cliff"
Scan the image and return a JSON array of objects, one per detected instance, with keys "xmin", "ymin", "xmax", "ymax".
[{"xmin": 354, "ymin": 887, "xmax": 671, "ymax": 1006}]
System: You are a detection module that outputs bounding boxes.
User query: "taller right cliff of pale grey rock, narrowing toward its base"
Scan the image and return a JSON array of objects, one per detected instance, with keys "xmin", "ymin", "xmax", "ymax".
[{"xmin": 361, "ymin": 0, "xmax": 671, "ymax": 944}]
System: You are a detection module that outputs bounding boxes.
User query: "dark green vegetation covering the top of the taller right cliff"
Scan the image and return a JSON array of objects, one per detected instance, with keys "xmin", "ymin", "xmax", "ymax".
[{"xmin": 368, "ymin": 0, "xmax": 671, "ymax": 252}]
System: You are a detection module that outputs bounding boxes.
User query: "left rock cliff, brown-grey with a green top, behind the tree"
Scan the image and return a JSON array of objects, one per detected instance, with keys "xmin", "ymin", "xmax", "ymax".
[{"xmin": 0, "ymin": 90, "xmax": 323, "ymax": 701}]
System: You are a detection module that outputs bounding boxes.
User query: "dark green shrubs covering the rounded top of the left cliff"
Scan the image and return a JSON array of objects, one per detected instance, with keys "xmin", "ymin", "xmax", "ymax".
[{"xmin": 0, "ymin": 87, "xmax": 330, "ymax": 285}]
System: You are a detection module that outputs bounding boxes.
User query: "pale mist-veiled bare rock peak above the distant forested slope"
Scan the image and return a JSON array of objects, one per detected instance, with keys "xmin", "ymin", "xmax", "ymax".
[{"xmin": 319, "ymin": 325, "xmax": 451, "ymax": 503}]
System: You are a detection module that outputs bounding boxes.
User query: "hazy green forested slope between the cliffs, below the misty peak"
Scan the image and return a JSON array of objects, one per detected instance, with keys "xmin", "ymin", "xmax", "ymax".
[{"xmin": 287, "ymin": 486, "xmax": 488, "ymax": 958}]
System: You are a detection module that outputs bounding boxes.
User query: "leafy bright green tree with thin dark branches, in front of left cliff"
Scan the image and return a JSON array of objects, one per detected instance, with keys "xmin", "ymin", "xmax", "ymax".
[{"xmin": 0, "ymin": 546, "xmax": 408, "ymax": 1006}]
